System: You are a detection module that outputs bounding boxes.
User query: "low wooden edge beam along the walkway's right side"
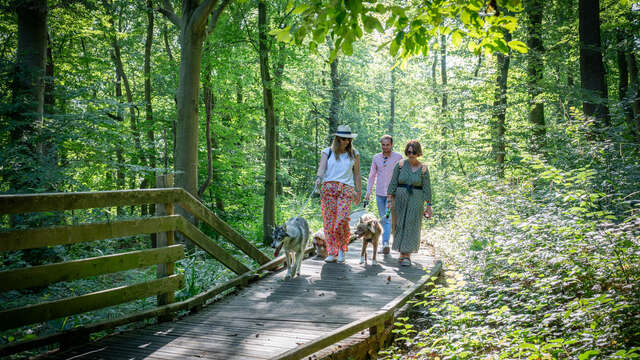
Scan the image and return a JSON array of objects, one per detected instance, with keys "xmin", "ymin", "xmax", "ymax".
[{"xmin": 270, "ymin": 260, "xmax": 442, "ymax": 360}]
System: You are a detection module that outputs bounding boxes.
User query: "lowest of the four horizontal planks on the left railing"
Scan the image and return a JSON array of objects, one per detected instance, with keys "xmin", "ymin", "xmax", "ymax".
[{"xmin": 0, "ymin": 274, "xmax": 184, "ymax": 330}]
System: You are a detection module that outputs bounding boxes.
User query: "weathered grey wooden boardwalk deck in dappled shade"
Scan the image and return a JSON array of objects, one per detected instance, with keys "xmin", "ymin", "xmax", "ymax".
[{"xmin": 46, "ymin": 242, "xmax": 435, "ymax": 360}]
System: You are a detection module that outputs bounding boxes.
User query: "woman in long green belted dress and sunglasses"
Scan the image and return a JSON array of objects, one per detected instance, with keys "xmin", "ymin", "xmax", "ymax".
[{"xmin": 387, "ymin": 140, "xmax": 433, "ymax": 266}]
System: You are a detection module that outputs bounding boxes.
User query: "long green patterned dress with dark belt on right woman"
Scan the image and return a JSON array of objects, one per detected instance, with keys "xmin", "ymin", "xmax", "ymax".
[{"xmin": 387, "ymin": 160, "xmax": 431, "ymax": 253}]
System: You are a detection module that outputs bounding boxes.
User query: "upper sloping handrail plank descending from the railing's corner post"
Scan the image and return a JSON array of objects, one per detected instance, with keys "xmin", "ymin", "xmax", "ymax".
[{"xmin": 180, "ymin": 191, "xmax": 271, "ymax": 265}]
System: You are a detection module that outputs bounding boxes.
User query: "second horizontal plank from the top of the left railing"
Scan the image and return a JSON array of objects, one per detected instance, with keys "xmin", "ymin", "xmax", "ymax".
[{"xmin": 0, "ymin": 215, "xmax": 180, "ymax": 251}]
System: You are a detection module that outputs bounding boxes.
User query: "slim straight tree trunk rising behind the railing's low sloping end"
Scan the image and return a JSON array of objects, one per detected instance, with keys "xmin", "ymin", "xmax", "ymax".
[{"xmin": 258, "ymin": 0, "xmax": 276, "ymax": 245}]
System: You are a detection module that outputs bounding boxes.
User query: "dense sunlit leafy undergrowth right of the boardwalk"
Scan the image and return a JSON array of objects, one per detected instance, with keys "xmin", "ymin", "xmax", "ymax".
[{"xmin": 381, "ymin": 161, "xmax": 640, "ymax": 360}]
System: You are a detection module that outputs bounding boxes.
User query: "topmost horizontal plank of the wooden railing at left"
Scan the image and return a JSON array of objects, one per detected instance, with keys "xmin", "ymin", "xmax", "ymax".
[{"xmin": 0, "ymin": 188, "xmax": 184, "ymax": 214}]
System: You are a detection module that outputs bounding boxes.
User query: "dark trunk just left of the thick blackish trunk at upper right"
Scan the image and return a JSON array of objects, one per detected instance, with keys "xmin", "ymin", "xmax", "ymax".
[{"xmin": 524, "ymin": 0, "xmax": 546, "ymax": 152}]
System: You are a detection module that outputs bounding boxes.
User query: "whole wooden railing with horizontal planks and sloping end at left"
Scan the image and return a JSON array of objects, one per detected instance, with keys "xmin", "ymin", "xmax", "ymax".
[{"xmin": 0, "ymin": 183, "xmax": 284, "ymax": 356}]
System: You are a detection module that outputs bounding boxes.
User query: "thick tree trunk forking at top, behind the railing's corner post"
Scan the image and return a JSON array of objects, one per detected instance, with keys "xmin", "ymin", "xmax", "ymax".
[{"xmin": 158, "ymin": 0, "xmax": 231, "ymax": 196}]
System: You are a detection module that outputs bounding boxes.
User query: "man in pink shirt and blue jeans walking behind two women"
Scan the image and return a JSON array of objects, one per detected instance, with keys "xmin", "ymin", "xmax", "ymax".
[{"xmin": 364, "ymin": 135, "xmax": 402, "ymax": 255}]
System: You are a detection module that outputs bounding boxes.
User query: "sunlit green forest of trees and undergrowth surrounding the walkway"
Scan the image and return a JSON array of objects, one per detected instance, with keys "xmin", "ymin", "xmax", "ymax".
[{"xmin": 0, "ymin": 0, "xmax": 640, "ymax": 360}]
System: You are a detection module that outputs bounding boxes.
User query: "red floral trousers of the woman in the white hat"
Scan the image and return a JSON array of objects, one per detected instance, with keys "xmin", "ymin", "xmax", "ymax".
[{"xmin": 321, "ymin": 181, "xmax": 356, "ymax": 256}]
